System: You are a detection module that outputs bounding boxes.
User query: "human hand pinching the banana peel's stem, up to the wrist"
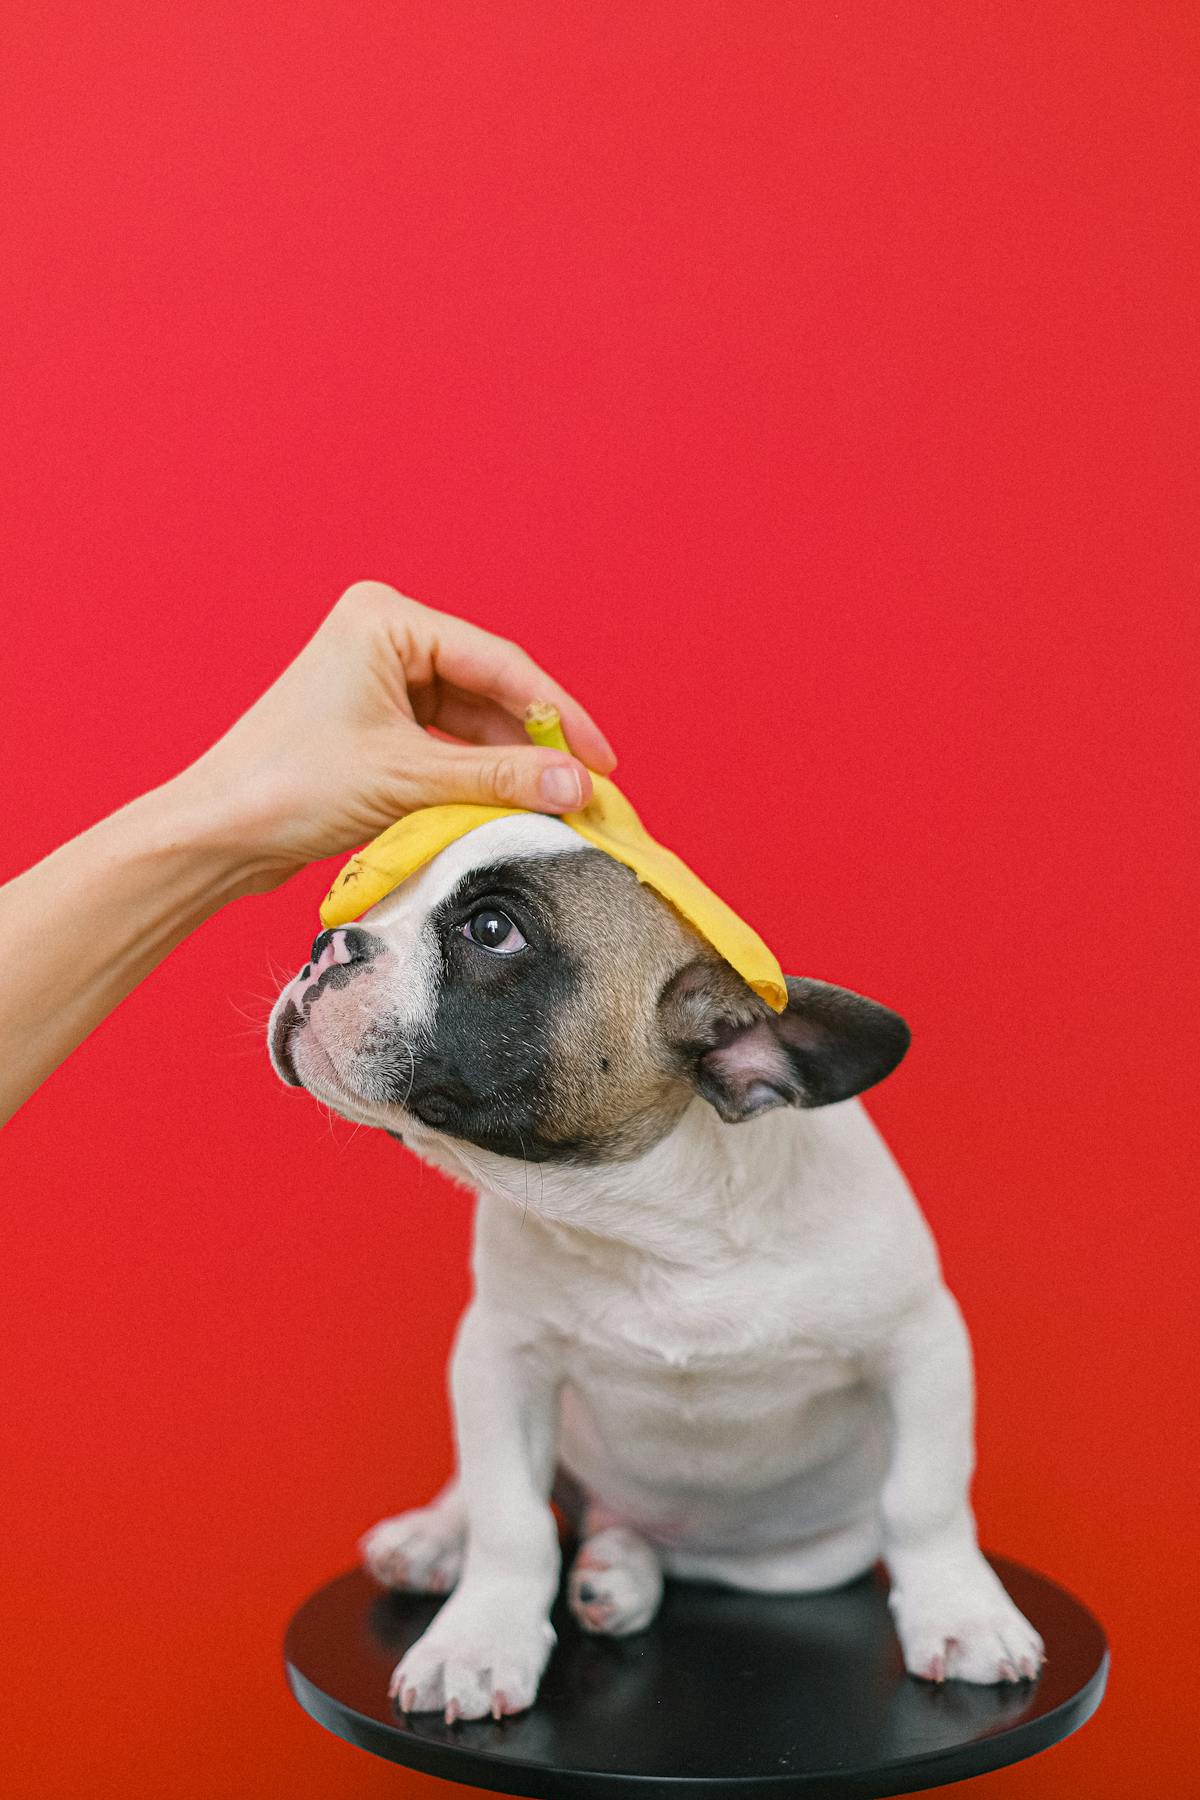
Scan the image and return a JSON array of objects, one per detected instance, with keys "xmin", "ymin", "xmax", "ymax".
[{"xmin": 173, "ymin": 581, "xmax": 615, "ymax": 889}]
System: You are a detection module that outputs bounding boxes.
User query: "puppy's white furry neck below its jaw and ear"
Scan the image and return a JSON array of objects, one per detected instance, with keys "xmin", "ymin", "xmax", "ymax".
[{"xmin": 412, "ymin": 1100, "xmax": 841, "ymax": 1265}]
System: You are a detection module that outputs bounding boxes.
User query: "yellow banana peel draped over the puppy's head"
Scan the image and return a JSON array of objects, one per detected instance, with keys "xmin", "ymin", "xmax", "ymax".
[{"xmin": 320, "ymin": 704, "xmax": 788, "ymax": 1012}]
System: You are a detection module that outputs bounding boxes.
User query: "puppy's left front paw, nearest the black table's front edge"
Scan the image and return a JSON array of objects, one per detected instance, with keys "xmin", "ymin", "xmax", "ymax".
[{"xmin": 389, "ymin": 1600, "xmax": 554, "ymax": 1724}]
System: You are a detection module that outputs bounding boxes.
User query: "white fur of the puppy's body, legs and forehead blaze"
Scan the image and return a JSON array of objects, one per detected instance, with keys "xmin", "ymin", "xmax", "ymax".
[{"xmin": 269, "ymin": 819, "xmax": 1042, "ymax": 1719}]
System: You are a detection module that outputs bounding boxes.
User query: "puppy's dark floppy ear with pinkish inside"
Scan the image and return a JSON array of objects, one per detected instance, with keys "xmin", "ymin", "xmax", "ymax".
[{"xmin": 658, "ymin": 958, "xmax": 909, "ymax": 1123}]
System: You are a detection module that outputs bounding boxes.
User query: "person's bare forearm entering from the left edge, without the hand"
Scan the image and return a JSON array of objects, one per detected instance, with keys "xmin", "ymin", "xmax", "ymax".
[{"xmin": 0, "ymin": 776, "xmax": 266, "ymax": 1123}]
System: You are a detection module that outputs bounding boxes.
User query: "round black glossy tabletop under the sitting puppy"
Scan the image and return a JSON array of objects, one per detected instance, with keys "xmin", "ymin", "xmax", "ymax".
[{"xmin": 284, "ymin": 1557, "xmax": 1108, "ymax": 1800}]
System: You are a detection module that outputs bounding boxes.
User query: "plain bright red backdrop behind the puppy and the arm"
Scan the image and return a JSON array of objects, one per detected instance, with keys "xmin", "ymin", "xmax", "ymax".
[{"xmin": 0, "ymin": 0, "xmax": 1198, "ymax": 1800}]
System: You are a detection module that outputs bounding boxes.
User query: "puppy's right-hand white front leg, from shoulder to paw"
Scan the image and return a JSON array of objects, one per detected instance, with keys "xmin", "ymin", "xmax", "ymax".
[{"xmin": 880, "ymin": 1287, "xmax": 1042, "ymax": 1683}]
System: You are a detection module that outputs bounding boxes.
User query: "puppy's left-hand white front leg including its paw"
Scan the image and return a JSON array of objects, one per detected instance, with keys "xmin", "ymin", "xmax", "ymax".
[{"xmin": 390, "ymin": 1301, "xmax": 560, "ymax": 1721}]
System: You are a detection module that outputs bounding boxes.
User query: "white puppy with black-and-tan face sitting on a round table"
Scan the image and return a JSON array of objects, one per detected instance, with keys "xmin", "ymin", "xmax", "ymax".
[{"xmin": 270, "ymin": 814, "xmax": 1042, "ymax": 1719}]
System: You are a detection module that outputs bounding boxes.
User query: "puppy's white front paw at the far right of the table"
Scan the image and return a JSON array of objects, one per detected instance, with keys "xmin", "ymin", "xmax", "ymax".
[{"xmin": 891, "ymin": 1559, "xmax": 1045, "ymax": 1685}]
